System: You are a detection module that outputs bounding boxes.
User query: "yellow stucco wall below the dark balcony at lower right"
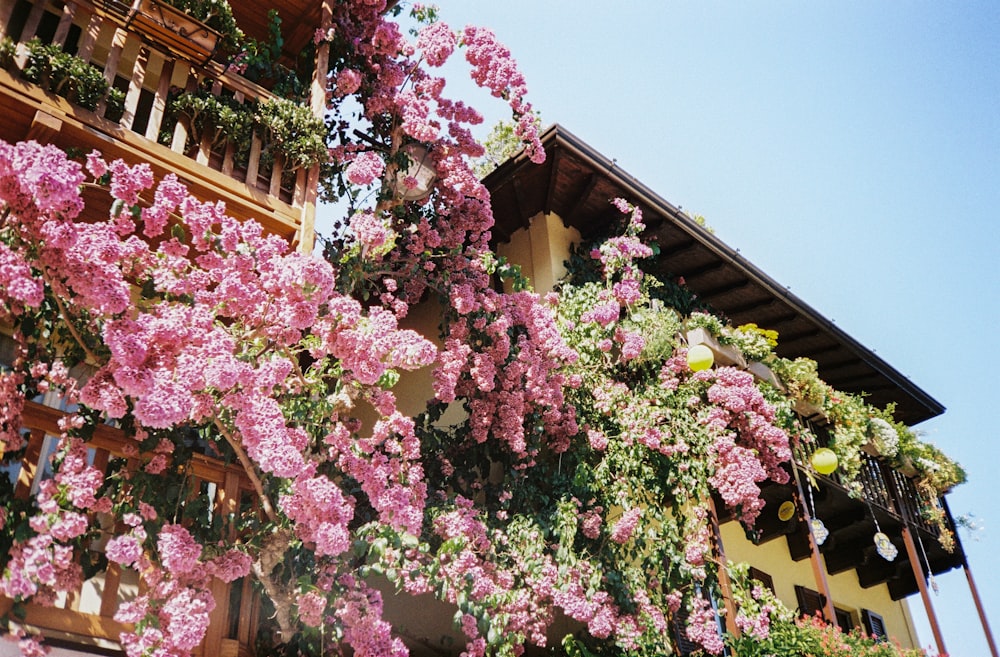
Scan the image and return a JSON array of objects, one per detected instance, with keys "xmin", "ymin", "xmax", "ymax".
[{"xmin": 721, "ymin": 522, "xmax": 919, "ymax": 648}]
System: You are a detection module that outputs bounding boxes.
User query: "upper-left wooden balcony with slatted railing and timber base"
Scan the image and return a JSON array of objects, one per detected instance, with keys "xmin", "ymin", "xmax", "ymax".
[{"xmin": 0, "ymin": 0, "xmax": 316, "ymax": 250}]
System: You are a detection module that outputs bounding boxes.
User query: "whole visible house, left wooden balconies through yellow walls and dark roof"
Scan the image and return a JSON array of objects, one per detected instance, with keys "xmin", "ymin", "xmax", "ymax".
[{"xmin": 0, "ymin": 0, "xmax": 996, "ymax": 655}]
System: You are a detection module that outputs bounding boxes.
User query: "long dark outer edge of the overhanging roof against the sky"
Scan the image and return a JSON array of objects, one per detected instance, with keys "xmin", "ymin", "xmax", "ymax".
[{"xmin": 508, "ymin": 123, "xmax": 945, "ymax": 421}]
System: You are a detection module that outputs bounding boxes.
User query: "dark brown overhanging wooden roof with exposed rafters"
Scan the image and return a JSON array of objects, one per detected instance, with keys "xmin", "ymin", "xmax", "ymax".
[{"xmin": 484, "ymin": 125, "xmax": 944, "ymax": 425}]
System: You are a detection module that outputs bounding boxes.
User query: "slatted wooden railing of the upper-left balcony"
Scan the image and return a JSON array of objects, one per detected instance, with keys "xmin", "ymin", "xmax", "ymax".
[{"xmin": 0, "ymin": 0, "xmax": 323, "ymax": 246}]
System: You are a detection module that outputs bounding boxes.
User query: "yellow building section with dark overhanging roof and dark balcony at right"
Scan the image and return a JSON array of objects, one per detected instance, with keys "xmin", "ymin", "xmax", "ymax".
[{"xmin": 485, "ymin": 125, "xmax": 996, "ymax": 655}]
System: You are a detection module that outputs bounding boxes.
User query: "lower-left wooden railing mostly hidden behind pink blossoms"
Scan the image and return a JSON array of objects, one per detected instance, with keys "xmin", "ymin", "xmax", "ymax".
[{"xmin": 0, "ymin": 402, "xmax": 258, "ymax": 657}]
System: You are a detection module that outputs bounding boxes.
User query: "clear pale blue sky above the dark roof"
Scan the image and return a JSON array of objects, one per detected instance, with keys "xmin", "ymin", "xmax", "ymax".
[{"xmin": 322, "ymin": 0, "xmax": 1000, "ymax": 657}]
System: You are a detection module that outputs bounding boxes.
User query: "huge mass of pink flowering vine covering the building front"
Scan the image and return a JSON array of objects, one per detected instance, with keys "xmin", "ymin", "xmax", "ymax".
[{"xmin": 0, "ymin": 5, "xmax": 836, "ymax": 657}]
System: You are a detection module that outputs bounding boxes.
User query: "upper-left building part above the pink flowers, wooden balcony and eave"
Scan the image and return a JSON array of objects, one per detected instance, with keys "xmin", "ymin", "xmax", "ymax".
[{"xmin": 0, "ymin": 0, "xmax": 328, "ymax": 251}]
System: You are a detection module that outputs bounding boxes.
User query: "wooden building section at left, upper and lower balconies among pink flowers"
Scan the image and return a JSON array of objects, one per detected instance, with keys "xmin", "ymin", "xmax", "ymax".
[{"xmin": 0, "ymin": 0, "xmax": 329, "ymax": 655}]
